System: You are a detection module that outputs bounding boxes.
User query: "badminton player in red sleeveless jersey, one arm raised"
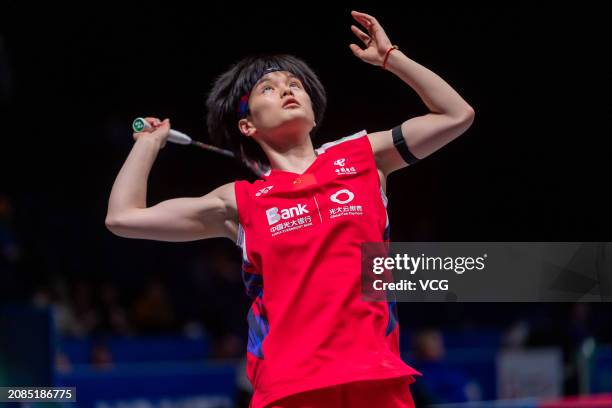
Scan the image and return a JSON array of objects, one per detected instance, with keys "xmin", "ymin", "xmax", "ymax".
[{"xmin": 106, "ymin": 11, "xmax": 474, "ymax": 408}]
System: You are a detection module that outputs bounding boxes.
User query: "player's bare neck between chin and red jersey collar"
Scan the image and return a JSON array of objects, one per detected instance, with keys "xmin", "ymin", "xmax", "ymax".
[{"xmin": 260, "ymin": 130, "xmax": 317, "ymax": 173}]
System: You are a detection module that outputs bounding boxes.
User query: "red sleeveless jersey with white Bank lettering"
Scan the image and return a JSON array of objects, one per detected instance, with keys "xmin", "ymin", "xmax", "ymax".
[{"xmin": 235, "ymin": 131, "xmax": 420, "ymax": 407}]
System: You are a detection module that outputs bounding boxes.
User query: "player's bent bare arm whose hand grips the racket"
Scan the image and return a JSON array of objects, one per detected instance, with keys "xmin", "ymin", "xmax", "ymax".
[{"xmin": 106, "ymin": 118, "xmax": 238, "ymax": 242}]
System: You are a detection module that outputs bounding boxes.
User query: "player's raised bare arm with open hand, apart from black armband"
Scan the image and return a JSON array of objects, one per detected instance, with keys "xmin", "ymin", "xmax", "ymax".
[{"xmin": 350, "ymin": 11, "xmax": 474, "ymax": 176}]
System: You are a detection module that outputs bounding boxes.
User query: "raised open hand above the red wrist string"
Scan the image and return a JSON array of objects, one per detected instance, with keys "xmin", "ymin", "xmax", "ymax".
[{"xmin": 349, "ymin": 11, "xmax": 392, "ymax": 66}]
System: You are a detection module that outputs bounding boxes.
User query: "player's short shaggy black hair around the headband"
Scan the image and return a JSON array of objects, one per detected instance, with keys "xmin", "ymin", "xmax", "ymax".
[{"xmin": 206, "ymin": 54, "xmax": 327, "ymax": 166}]
